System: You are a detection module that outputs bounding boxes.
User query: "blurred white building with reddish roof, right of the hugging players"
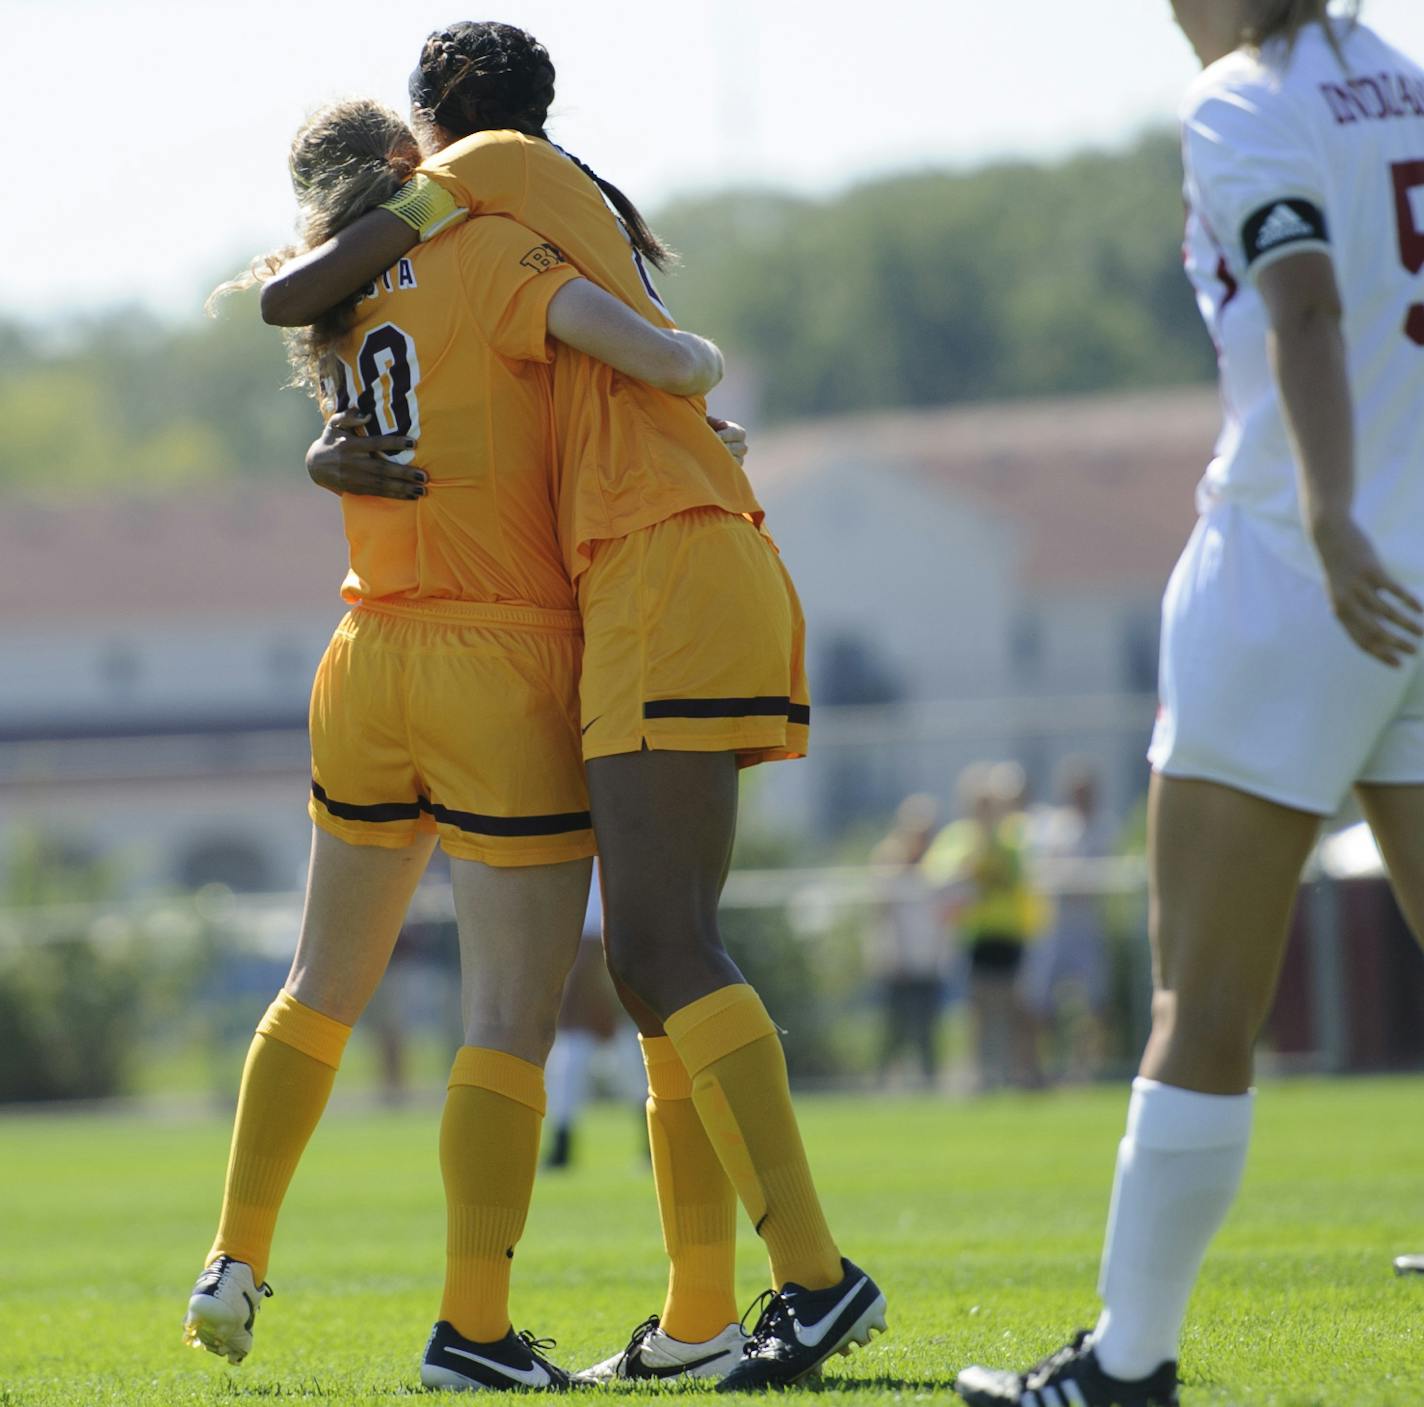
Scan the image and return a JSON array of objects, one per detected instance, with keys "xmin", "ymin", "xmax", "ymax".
[{"xmin": 748, "ymin": 387, "xmax": 1219, "ymax": 830}]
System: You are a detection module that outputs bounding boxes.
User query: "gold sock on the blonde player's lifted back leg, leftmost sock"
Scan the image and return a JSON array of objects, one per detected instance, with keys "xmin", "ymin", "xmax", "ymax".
[{"xmin": 208, "ymin": 988, "xmax": 352, "ymax": 1285}]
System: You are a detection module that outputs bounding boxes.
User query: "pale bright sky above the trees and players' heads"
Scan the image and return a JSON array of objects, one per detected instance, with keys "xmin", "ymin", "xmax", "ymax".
[{"xmin": 11, "ymin": 0, "xmax": 1424, "ymax": 319}]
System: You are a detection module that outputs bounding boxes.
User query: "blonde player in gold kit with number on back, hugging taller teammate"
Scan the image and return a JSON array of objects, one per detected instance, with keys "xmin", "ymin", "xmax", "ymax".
[{"xmin": 185, "ymin": 103, "xmax": 721, "ymax": 1388}]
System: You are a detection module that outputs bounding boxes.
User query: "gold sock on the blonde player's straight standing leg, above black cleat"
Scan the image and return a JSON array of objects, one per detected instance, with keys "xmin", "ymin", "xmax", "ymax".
[{"xmin": 440, "ymin": 1045, "xmax": 544, "ymax": 1343}]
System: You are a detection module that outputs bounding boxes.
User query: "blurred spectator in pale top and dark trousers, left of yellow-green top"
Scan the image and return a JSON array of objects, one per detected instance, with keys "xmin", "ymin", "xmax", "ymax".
[{"xmin": 869, "ymin": 795, "xmax": 948, "ymax": 1088}]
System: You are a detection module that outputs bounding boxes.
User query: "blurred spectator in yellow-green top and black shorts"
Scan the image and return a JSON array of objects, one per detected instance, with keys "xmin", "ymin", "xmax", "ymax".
[{"xmin": 923, "ymin": 762, "xmax": 1044, "ymax": 1091}]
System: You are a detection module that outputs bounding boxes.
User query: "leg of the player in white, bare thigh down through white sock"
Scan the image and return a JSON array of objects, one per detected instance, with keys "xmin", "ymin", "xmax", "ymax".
[{"xmin": 1094, "ymin": 776, "xmax": 1319, "ymax": 1379}]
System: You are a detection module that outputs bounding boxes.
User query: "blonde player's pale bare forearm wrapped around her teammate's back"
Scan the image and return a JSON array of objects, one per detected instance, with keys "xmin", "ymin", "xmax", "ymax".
[{"xmin": 548, "ymin": 278, "xmax": 723, "ymax": 396}]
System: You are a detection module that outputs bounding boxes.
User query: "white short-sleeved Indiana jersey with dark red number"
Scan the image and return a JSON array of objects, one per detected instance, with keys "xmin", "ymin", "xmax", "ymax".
[{"xmin": 1182, "ymin": 24, "xmax": 1424, "ymax": 590}]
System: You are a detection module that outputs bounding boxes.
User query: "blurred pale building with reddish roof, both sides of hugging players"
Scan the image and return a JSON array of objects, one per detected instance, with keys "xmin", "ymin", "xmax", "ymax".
[{"xmin": 0, "ymin": 389, "xmax": 1216, "ymax": 890}]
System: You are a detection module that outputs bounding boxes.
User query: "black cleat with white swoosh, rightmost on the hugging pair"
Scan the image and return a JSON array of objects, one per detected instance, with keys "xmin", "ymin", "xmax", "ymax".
[{"xmin": 718, "ymin": 1259, "xmax": 886, "ymax": 1393}]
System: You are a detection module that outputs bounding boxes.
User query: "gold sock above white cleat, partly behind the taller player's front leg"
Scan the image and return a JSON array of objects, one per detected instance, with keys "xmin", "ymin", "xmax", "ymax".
[{"xmin": 639, "ymin": 1035, "xmax": 738, "ymax": 1343}]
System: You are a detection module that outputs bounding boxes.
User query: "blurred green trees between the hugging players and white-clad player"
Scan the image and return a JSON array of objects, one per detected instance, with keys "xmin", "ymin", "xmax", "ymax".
[{"xmin": 658, "ymin": 134, "xmax": 1213, "ymax": 420}]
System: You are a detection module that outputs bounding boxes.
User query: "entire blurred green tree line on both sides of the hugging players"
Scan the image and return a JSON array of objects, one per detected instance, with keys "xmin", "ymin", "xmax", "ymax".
[{"xmin": 0, "ymin": 134, "xmax": 1212, "ymax": 493}]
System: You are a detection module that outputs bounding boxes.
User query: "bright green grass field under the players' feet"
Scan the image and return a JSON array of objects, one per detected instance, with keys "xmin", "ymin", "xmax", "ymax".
[{"xmin": 0, "ymin": 1081, "xmax": 1424, "ymax": 1407}]
